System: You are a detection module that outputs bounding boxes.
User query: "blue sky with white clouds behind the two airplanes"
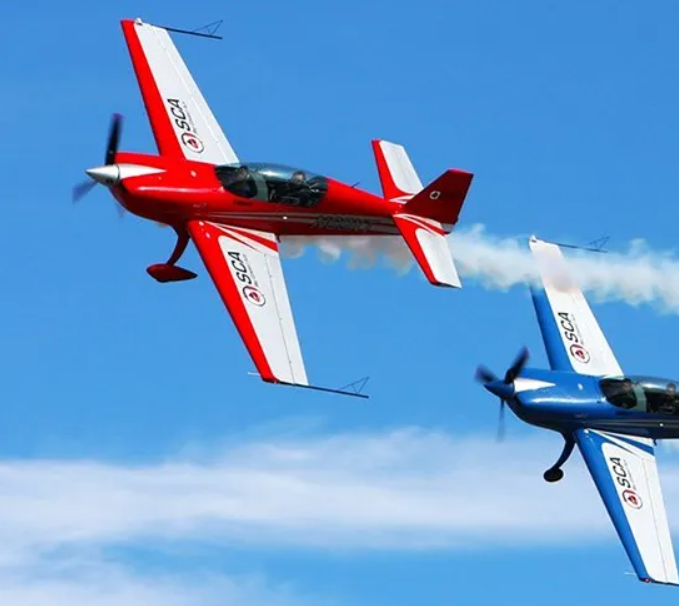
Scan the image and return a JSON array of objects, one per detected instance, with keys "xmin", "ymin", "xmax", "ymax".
[{"xmin": 0, "ymin": 0, "xmax": 679, "ymax": 606}]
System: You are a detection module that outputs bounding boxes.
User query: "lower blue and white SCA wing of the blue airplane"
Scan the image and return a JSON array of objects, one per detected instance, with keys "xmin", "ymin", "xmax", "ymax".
[{"xmin": 575, "ymin": 429, "xmax": 679, "ymax": 585}]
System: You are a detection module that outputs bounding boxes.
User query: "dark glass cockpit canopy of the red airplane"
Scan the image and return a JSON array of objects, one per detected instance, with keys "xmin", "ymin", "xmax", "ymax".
[{"xmin": 215, "ymin": 162, "xmax": 328, "ymax": 208}]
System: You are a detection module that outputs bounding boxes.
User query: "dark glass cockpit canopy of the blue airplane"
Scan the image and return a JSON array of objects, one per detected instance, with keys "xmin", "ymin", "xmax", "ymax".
[{"xmin": 599, "ymin": 376, "xmax": 679, "ymax": 415}]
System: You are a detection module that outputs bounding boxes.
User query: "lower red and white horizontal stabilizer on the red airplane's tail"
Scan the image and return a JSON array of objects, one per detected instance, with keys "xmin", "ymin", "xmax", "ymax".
[{"xmin": 394, "ymin": 214, "xmax": 462, "ymax": 288}]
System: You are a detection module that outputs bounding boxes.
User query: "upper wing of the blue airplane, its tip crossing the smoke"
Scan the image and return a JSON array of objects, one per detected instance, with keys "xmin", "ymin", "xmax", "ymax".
[{"xmin": 529, "ymin": 236, "xmax": 622, "ymax": 376}]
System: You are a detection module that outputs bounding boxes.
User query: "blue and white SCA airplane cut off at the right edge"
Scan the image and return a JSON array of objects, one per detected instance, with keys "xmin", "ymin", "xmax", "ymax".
[{"xmin": 477, "ymin": 236, "xmax": 679, "ymax": 585}]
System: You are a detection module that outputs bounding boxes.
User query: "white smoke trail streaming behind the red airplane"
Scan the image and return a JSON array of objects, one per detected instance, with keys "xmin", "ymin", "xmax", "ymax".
[{"xmin": 284, "ymin": 225, "xmax": 679, "ymax": 313}]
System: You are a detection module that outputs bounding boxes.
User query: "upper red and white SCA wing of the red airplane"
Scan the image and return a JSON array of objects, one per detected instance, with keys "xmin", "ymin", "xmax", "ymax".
[{"xmin": 122, "ymin": 19, "xmax": 238, "ymax": 164}]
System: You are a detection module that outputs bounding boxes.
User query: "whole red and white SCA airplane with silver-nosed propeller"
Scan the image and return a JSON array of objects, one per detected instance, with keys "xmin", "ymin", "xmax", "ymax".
[{"xmin": 73, "ymin": 19, "xmax": 473, "ymax": 395}]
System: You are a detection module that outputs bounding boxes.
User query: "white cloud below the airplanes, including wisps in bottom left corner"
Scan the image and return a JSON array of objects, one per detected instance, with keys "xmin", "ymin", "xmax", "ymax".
[{"xmin": 5, "ymin": 429, "xmax": 679, "ymax": 606}]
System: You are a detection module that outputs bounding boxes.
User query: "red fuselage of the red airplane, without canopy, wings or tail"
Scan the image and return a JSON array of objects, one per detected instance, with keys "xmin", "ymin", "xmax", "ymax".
[{"xmin": 111, "ymin": 153, "xmax": 402, "ymax": 236}]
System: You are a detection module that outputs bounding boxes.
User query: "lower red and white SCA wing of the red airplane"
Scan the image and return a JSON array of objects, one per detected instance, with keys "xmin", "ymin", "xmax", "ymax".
[{"xmin": 188, "ymin": 221, "xmax": 309, "ymax": 385}]
